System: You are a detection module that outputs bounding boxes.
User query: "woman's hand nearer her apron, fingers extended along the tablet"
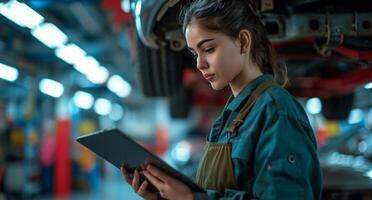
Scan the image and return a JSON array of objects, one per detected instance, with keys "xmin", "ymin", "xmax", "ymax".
[{"xmin": 143, "ymin": 165, "xmax": 193, "ymax": 200}]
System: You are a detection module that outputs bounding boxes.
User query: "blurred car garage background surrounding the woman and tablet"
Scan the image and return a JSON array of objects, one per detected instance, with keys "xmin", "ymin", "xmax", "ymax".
[{"xmin": 0, "ymin": 0, "xmax": 372, "ymax": 200}]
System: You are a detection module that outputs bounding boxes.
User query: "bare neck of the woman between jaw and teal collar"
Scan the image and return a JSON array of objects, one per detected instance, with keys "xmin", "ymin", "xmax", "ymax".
[{"xmin": 229, "ymin": 66, "xmax": 262, "ymax": 97}]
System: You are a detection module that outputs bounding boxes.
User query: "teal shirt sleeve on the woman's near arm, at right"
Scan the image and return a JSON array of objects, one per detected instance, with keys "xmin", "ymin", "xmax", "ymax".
[{"xmin": 253, "ymin": 114, "xmax": 321, "ymax": 200}]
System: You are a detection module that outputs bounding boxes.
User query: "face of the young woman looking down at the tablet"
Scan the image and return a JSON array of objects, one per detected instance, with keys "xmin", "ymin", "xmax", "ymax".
[{"xmin": 185, "ymin": 21, "xmax": 244, "ymax": 90}]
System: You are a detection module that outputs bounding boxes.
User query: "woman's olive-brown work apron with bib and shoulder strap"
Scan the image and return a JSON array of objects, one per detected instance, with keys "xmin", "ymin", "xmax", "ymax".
[{"xmin": 196, "ymin": 80, "xmax": 276, "ymax": 193}]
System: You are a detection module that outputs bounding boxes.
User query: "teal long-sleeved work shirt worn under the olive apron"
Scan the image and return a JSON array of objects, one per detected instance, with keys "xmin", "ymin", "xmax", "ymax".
[{"xmin": 194, "ymin": 75, "xmax": 322, "ymax": 200}]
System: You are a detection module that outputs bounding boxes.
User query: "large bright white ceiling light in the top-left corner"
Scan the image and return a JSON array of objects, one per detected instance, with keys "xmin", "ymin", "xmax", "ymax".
[{"xmin": 0, "ymin": 0, "xmax": 44, "ymax": 29}]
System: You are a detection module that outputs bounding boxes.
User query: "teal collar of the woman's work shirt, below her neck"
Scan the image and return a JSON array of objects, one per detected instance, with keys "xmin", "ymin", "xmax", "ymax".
[{"xmin": 225, "ymin": 74, "xmax": 273, "ymax": 111}]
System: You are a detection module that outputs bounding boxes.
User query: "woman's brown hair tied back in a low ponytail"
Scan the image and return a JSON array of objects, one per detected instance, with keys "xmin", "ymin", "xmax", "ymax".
[{"xmin": 180, "ymin": 0, "xmax": 288, "ymax": 86}]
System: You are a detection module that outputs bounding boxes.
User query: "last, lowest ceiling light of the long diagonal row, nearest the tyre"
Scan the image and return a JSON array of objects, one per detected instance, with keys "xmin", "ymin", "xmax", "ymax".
[{"xmin": 107, "ymin": 75, "xmax": 132, "ymax": 98}]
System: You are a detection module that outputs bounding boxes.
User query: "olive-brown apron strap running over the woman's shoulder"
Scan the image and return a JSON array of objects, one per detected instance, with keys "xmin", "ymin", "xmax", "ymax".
[{"xmin": 227, "ymin": 80, "xmax": 277, "ymax": 136}]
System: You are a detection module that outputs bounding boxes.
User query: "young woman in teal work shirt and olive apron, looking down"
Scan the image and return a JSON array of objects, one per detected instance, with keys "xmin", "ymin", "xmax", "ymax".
[{"xmin": 122, "ymin": 0, "xmax": 322, "ymax": 200}]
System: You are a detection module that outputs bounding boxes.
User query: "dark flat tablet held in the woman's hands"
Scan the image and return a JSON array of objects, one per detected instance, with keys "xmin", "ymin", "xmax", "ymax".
[{"xmin": 76, "ymin": 128, "xmax": 205, "ymax": 192}]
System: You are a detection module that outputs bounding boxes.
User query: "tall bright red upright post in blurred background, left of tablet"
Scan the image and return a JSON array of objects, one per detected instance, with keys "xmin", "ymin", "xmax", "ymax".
[{"xmin": 53, "ymin": 119, "xmax": 71, "ymax": 197}]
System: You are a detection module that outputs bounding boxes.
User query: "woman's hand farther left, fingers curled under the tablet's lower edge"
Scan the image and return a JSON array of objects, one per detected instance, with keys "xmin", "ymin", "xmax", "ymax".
[{"xmin": 120, "ymin": 164, "xmax": 157, "ymax": 200}]
